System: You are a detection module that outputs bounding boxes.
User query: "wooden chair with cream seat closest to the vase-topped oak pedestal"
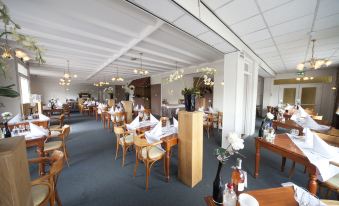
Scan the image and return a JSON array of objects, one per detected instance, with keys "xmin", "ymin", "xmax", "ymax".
[{"xmin": 134, "ymin": 134, "xmax": 166, "ymax": 191}]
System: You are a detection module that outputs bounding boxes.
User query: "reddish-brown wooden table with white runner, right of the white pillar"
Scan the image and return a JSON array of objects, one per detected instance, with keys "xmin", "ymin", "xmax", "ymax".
[{"xmin": 254, "ymin": 134, "xmax": 318, "ymax": 194}]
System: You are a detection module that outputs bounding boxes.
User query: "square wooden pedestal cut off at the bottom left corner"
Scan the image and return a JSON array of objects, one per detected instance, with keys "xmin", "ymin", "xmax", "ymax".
[{"xmin": 0, "ymin": 137, "xmax": 33, "ymax": 206}]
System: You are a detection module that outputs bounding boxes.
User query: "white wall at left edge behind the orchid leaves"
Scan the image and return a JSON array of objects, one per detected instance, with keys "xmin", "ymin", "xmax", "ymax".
[{"xmin": 0, "ymin": 59, "xmax": 21, "ymax": 115}]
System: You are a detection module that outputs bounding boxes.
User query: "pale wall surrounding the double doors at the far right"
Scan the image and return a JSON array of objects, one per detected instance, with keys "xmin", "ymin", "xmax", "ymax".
[{"xmin": 263, "ymin": 68, "xmax": 337, "ymax": 120}]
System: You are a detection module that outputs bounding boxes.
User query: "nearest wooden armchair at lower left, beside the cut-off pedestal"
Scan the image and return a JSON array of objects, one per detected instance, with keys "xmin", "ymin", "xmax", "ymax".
[{"xmin": 28, "ymin": 150, "xmax": 64, "ymax": 206}]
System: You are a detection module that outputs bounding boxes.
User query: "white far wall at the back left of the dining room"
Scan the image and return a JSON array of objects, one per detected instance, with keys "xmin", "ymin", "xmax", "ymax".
[{"xmin": 31, "ymin": 76, "xmax": 103, "ymax": 104}]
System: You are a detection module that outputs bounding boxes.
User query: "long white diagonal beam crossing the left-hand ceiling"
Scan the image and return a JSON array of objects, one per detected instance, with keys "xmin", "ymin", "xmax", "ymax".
[{"xmin": 87, "ymin": 20, "xmax": 163, "ymax": 79}]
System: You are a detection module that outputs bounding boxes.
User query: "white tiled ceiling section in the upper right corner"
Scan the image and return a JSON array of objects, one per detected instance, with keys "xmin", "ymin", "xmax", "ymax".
[{"xmin": 202, "ymin": 0, "xmax": 339, "ymax": 73}]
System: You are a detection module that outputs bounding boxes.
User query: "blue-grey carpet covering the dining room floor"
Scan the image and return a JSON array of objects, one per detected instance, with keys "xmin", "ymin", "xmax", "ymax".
[{"xmin": 29, "ymin": 114, "xmax": 330, "ymax": 206}]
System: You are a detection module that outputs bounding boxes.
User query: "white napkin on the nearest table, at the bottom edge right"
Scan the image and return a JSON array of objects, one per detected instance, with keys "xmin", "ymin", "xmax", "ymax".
[{"xmin": 281, "ymin": 182, "xmax": 326, "ymax": 206}]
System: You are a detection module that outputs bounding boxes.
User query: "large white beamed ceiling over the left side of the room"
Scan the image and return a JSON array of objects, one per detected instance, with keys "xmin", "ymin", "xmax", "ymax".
[{"xmin": 4, "ymin": 0, "xmax": 226, "ymax": 83}]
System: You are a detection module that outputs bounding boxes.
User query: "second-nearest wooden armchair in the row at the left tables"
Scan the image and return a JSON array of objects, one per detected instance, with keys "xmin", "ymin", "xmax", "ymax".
[{"xmin": 44, "ymin": 125, "xmax": 71, "ymax": 166}]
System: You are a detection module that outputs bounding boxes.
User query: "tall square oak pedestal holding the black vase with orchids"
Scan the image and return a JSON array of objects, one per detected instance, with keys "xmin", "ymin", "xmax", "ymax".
[{"xmin": 178, "ymin": 111, "xmax": 203, "ymax": 187}]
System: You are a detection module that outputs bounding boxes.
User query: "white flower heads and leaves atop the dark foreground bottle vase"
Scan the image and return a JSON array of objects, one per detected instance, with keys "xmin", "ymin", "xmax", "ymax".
[{"xmin": 214, "ymin": 132, "xmax": 244, "ymax": 163}]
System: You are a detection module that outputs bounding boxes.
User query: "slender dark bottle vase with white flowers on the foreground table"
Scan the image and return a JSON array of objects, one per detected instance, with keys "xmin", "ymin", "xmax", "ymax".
[{"xmin": 213, "ymin": 132, "xmax": 244, "ymax": 205}]
